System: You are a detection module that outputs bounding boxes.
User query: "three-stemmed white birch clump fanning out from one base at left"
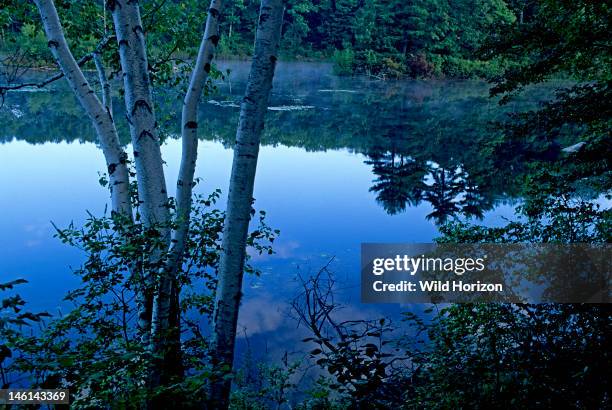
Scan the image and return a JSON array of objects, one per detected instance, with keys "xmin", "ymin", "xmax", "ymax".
[{"xmin": 36, "ymin": 0, "xmax": 222, "ymax": 384}]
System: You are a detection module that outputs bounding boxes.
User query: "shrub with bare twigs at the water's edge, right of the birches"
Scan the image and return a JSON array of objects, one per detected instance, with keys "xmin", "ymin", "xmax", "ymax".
[{"xmin": 292, "ymin": 261, "xmax": 409, "ymax": 408}]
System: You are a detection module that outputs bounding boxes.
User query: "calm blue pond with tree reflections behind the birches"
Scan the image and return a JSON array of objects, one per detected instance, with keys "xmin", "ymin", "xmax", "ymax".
[{"xmin": 0, "ymin": 61, "xmax": 550, "ymax": 358}]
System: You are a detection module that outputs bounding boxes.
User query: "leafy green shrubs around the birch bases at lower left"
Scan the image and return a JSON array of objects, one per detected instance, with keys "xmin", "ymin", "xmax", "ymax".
[{"xmin": 0, "ymin": 190, "xmax": 278, "ymax": 408}]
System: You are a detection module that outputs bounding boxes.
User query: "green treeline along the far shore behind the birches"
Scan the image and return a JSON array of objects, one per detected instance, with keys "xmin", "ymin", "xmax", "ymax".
[{"xmin": 0, "ymin": 0, "xmax": 539, "ymax": 78}]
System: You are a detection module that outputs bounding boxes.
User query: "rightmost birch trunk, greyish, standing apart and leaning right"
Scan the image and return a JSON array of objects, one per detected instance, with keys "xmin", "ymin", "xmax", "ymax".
[{"xmin": 210, "ymin": 0, "xmax": 283, "ymax": 408}]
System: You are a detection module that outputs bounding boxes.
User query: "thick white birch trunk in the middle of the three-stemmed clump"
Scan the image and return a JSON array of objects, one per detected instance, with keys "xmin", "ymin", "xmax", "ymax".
[{"xmin": 108, "ymin": 0, "xmax": 171, "ymax": 350}]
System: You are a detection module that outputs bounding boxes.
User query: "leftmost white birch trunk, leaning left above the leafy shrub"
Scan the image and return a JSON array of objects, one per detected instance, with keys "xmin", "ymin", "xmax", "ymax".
[{"xmin": 35, "ymin": 0, "xmax": 132, "ymax": 218}]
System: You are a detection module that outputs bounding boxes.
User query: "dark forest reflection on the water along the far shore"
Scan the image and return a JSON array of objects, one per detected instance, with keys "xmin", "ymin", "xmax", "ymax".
[{"xmin": 0, "ymin": 62, "xmax": 549, "ymax": 223}]
